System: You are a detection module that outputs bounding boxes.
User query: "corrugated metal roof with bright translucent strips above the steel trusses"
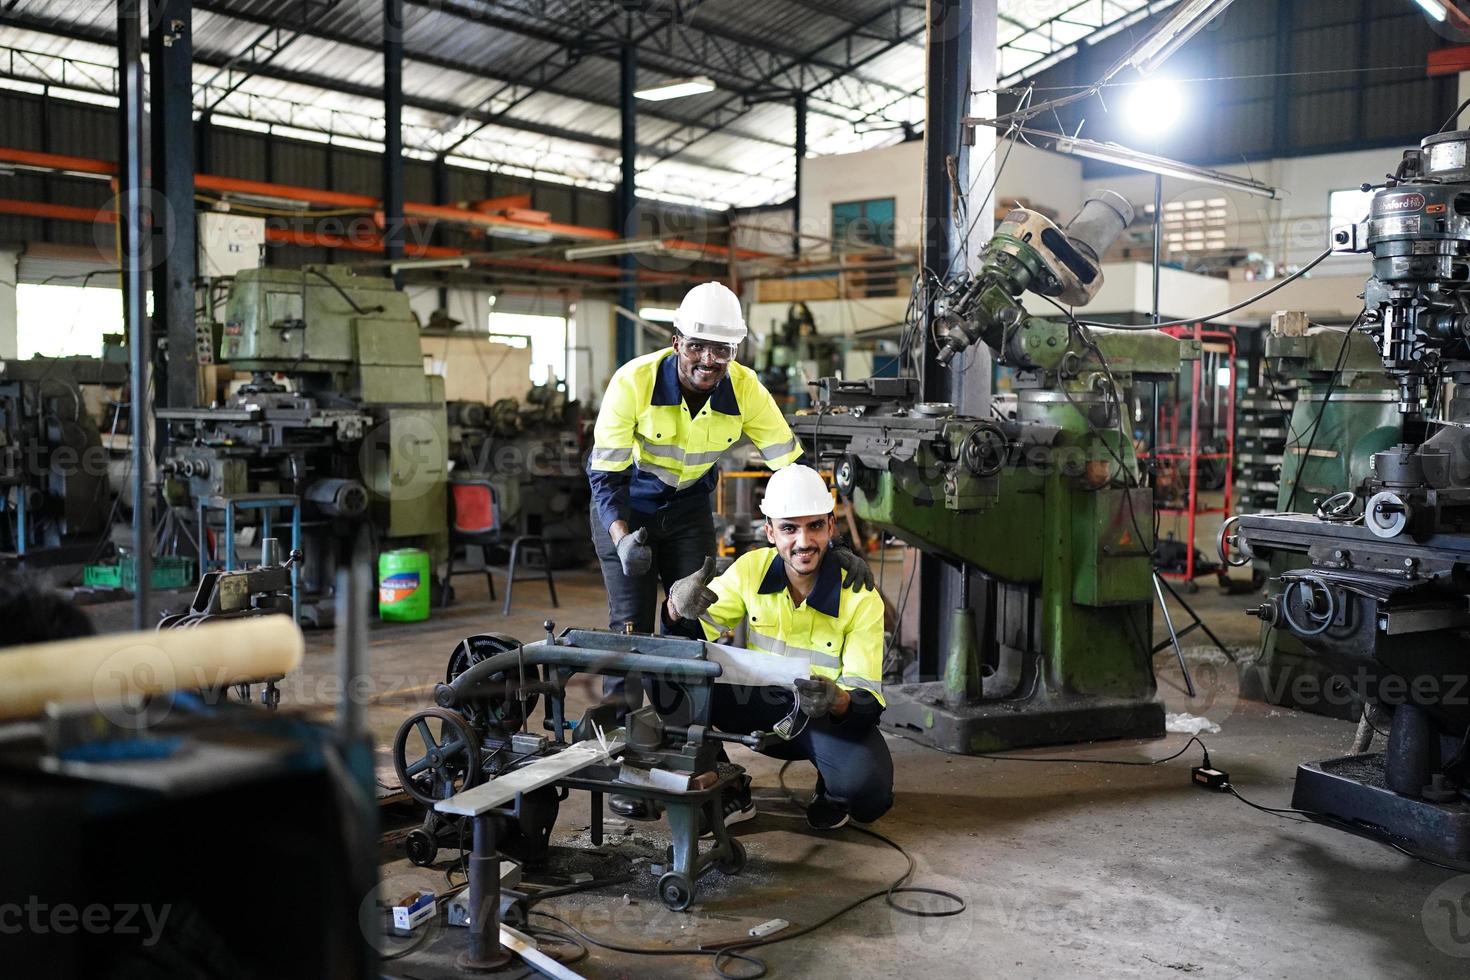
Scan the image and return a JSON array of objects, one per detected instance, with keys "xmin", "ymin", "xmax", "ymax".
[{"xmin": 0, "ymin": 0, "xmax": 1173, "ymax": 207}]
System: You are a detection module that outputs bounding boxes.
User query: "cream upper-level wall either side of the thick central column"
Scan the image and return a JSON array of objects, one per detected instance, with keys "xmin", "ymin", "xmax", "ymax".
[{"xmin": 801, "ymin": 140, "xmax": 1083, "ymax": 251}]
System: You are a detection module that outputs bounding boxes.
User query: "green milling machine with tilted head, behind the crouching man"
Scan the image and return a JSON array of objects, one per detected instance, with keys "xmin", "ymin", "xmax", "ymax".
[{"xmin": 792, "ymin": 192, "xmax": 1198, "ymax": 754}]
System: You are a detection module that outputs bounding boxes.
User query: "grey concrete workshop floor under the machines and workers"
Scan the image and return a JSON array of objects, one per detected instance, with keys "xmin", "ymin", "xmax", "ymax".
[{"xmin": 85, "ymin": 558, "xmax": 1470, "ymax": 980}]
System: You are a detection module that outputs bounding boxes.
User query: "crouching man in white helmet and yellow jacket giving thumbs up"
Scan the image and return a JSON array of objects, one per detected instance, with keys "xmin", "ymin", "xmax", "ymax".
[{"xmin": 663, "ymin": 464, "xmax": 894, "ymax": 830}]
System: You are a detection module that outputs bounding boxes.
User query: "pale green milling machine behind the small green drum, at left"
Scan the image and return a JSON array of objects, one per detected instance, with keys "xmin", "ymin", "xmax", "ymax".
[{"xmin": 157, "ymin": 266, "xmax": 448, "ymax": 626}]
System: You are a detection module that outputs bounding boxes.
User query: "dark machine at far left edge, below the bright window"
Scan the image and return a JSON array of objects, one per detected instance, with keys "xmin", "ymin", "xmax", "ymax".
[{"xmin": 0, "ymin": 357, "xmax": 128, "ymax": 564}]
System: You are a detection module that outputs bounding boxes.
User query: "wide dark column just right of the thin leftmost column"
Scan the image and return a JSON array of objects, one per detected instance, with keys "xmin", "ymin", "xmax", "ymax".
[{"xmin": 148, "ymin": 0, "xmax": 200, "ymax": 408}]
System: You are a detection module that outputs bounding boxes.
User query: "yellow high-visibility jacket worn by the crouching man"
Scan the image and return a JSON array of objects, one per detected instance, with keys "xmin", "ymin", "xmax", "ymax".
[{"xmin": 700, "ymin": 548, "xmax": 886, "ymax": 705}]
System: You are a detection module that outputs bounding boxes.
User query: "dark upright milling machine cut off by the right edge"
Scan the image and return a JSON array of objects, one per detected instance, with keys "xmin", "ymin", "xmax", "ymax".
[{"xmin": 1223, "ymin": 131, "xmax": 1470, "ymax": 860}]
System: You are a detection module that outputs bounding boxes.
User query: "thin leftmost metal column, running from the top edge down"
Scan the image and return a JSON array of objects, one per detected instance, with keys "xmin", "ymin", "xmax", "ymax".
[{"xmin": 118, "ymin": 0, "xmax": 149, "ymax": 630}]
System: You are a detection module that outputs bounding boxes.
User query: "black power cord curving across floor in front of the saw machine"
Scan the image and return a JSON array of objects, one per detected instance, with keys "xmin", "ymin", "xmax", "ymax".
[{"xmin": 531, "ymin": 761, "xmax": 969, "ymax": 980}]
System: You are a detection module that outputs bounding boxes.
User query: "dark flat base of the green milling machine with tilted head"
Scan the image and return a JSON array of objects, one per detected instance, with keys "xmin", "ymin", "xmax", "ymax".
[{"xmin": 882, "ymin": 682, "xmax": 1164, "ymax": 755}]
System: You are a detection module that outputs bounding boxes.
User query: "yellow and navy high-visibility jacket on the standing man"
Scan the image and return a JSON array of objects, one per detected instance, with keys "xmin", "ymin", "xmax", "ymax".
[{"xmin": 587, "ymin": 347, "xmax": 803, "ymax": 527}]
